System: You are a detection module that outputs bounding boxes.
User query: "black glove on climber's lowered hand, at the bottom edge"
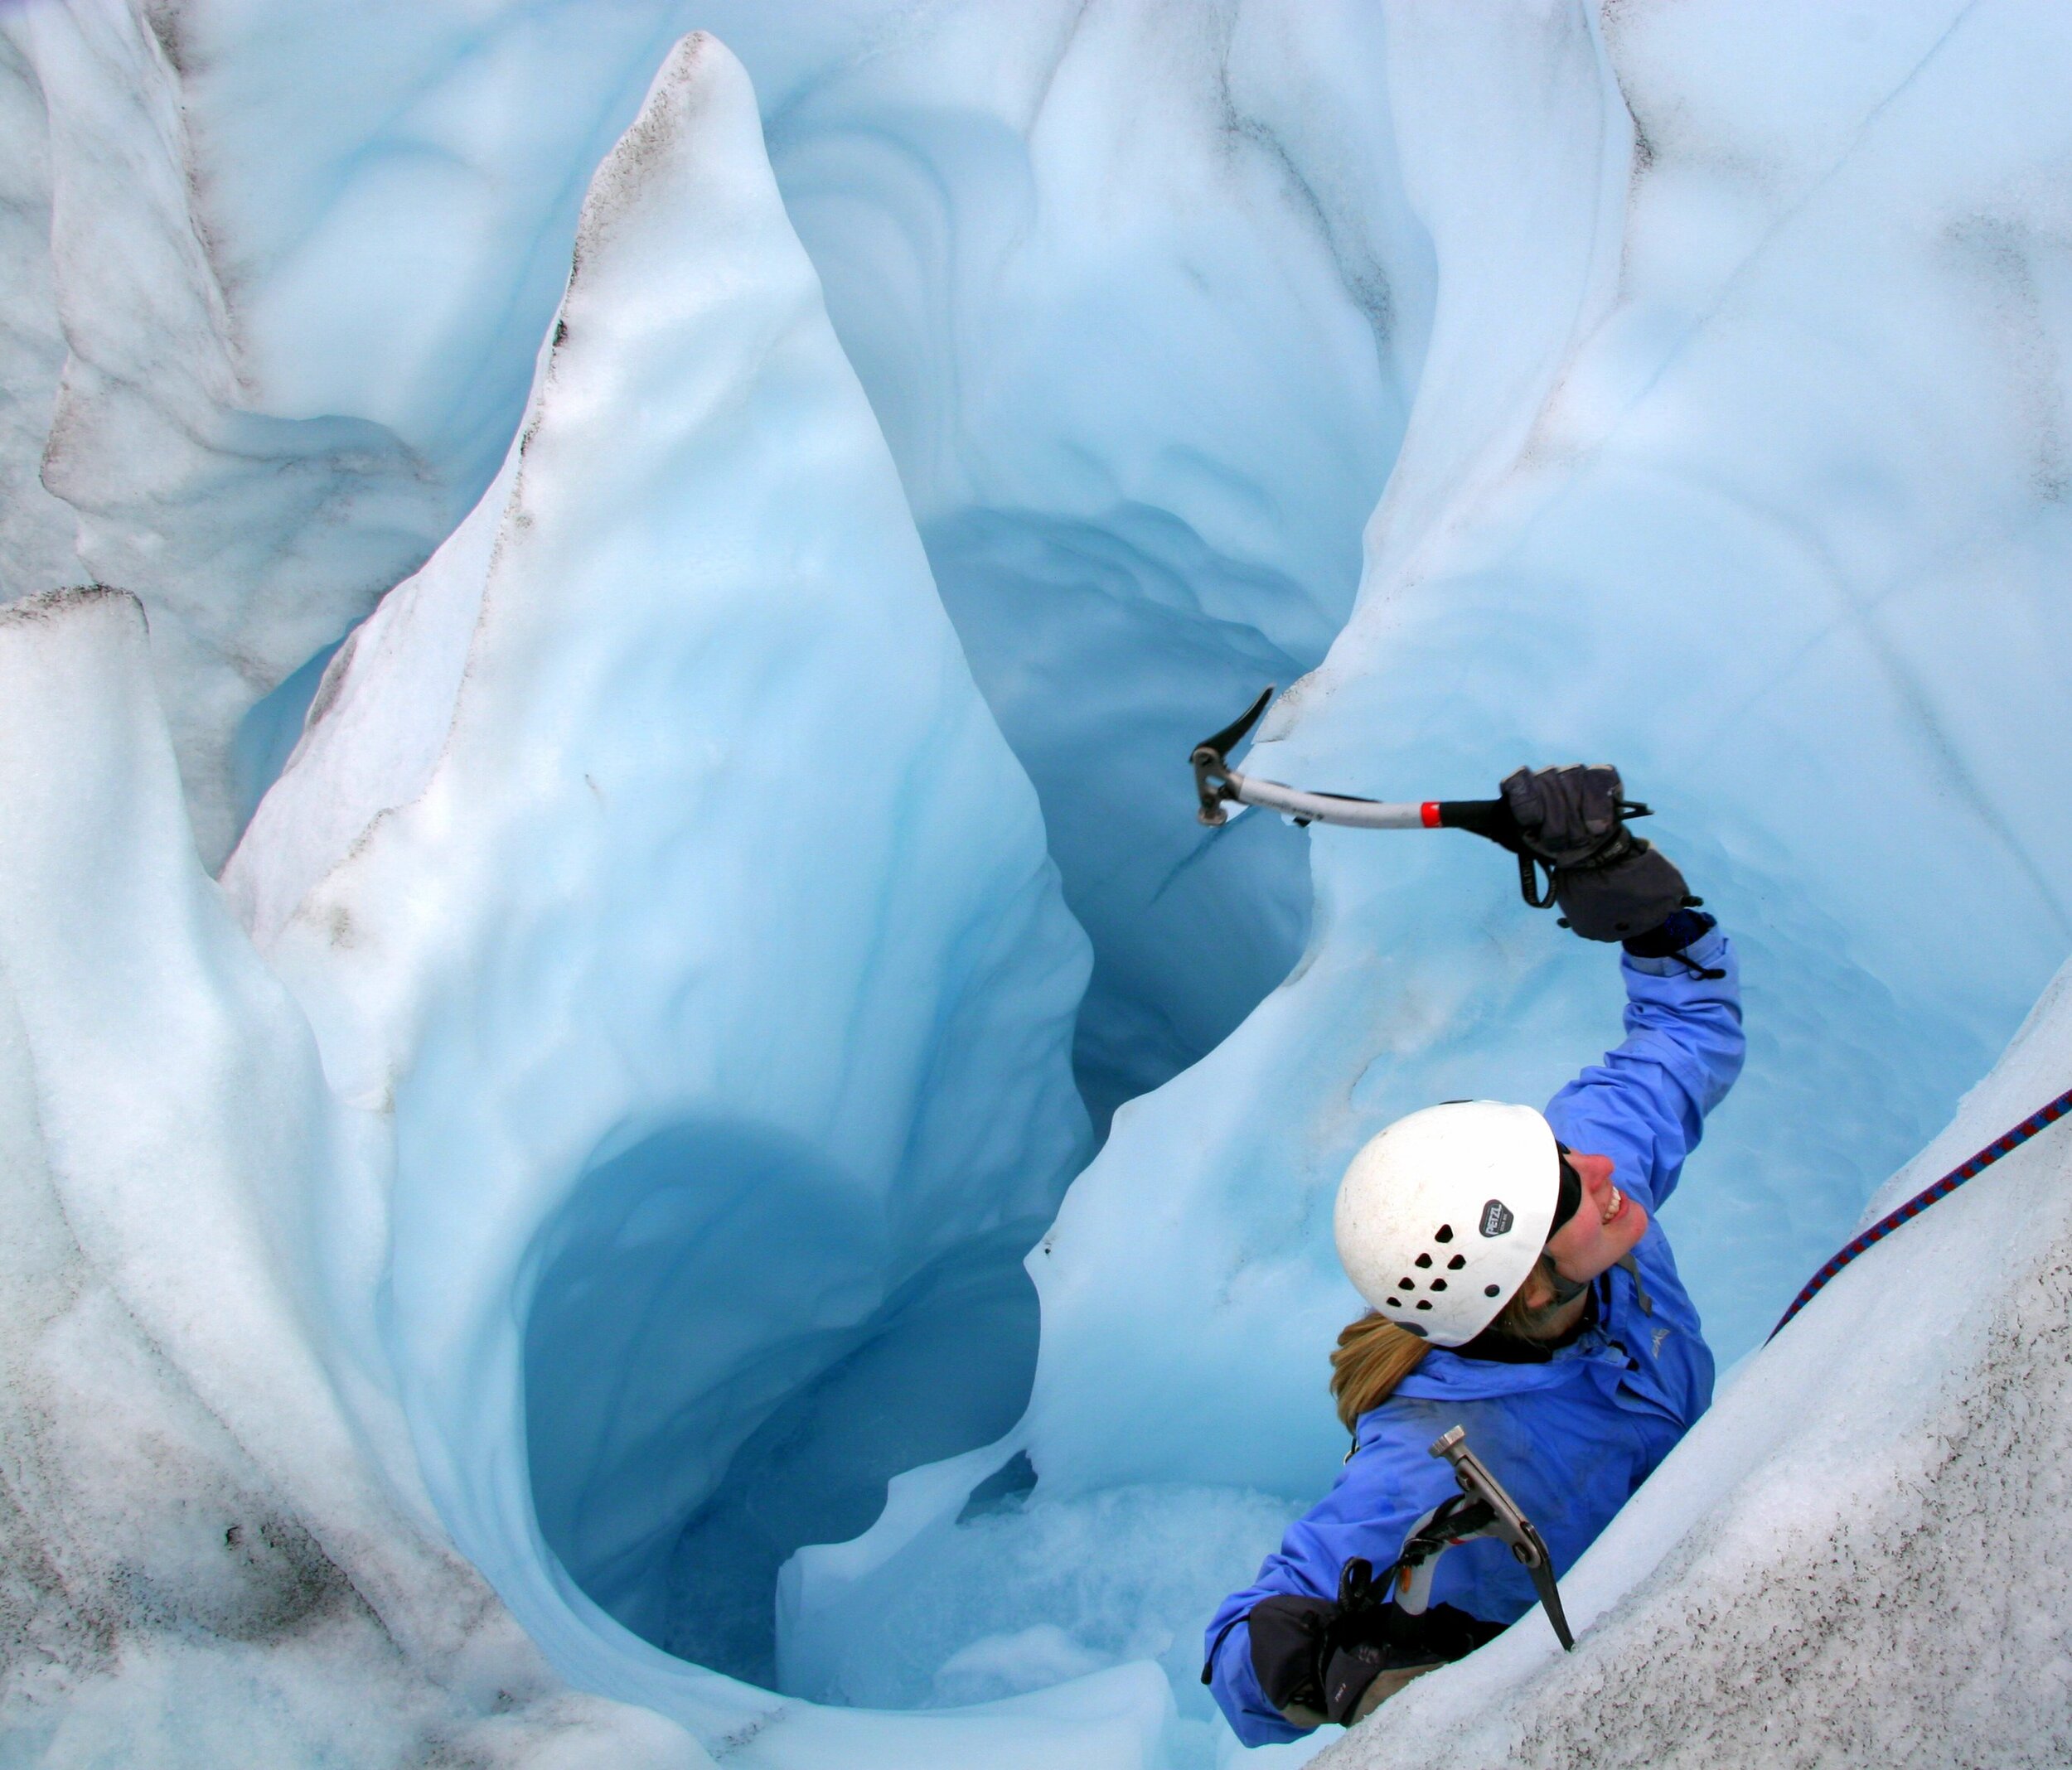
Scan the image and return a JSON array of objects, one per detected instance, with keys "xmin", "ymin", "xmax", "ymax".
[{"xmin": 1246, "ymin": 1559, "xmax": 1504, "ymax": 1726}]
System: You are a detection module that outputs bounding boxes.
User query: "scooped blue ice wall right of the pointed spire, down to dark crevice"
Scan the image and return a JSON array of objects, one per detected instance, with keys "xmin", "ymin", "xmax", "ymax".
[{"xmin": 750, "ymin": 0, "xmax": 1434, "ymax": 1125}]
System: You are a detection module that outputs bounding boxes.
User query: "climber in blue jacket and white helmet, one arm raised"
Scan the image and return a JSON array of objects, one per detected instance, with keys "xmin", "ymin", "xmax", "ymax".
[{"xmin": 1204, "ymin": 767, "xmax": 1743, "ymax": 1745}]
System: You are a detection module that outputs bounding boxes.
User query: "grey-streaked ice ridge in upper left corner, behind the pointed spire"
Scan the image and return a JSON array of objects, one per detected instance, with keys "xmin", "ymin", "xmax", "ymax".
[{"xmin": 0, "ymin": 2, "xmax": 454, "ymax": 860}]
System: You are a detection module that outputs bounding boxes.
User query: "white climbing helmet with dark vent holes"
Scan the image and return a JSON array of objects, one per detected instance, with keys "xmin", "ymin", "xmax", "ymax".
[{"xmin": 1334, "ymin": 1100, "xmax": 1561, "ymax": 1345}]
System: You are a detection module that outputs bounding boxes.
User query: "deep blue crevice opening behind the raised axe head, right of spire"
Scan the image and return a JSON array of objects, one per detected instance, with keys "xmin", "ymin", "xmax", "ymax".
[{"xmin": 922, "ymin": 505, "xmax": 1318, "ymax": 1138}]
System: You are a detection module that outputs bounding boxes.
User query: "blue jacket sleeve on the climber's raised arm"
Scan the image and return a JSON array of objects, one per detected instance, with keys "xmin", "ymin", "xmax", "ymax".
[{"xmin": 1548, "ymin": 929, "xmax": 1745, "ymax": 1208}]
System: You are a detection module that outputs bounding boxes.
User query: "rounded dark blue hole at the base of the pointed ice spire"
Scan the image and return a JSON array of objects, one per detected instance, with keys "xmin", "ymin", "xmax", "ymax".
[{"xmin": 525, "ymin": 1124, "xmax": 1044, "ymax": 1685}]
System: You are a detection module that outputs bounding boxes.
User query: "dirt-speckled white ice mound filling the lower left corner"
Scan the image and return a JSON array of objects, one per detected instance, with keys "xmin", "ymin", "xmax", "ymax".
[{"xmin": 0, "ymin": 591, "xmax": 700, "ymax": 1768}]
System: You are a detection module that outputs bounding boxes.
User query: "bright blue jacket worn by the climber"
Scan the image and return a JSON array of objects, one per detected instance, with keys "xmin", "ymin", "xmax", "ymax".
[{"xmin": 1208, "ymin": 929, "xmax": 1743, "ymax": 1745}]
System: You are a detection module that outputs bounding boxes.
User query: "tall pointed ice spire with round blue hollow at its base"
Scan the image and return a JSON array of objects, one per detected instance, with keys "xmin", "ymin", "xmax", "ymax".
[{"xmin": 226, "ymin": 37, "xmax": 1164, "ymax": 1753}]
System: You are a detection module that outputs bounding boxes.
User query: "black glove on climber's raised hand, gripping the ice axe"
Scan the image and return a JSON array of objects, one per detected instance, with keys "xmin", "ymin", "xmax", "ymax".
[{"xmin": 1504, "ymin": 762, "xmax": 1697, "ymax": 941}]
